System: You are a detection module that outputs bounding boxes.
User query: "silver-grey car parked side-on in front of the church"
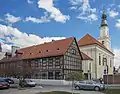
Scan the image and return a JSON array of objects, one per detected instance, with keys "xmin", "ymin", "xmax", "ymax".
[{"xmin": 74, "ymin": 80, "xmax": 105, "ymax": 91}]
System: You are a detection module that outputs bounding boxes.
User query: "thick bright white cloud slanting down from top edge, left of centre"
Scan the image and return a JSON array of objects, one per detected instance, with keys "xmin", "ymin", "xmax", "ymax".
[{"xmin": 38, "ymin": 0, "xmax": 70, "ymax": 23}]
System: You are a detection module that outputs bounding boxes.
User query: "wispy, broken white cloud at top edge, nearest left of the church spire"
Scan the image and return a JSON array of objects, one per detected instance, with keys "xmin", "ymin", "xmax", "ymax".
[{"xmin": 69, "ymin": 0, "xmax": 98, "ymax": 21}]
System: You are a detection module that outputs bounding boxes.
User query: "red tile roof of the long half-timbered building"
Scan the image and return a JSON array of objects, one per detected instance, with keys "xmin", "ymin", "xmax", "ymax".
[{"xmin": 0, "ymin": 37, "xmax": 75, "ymax": 60}]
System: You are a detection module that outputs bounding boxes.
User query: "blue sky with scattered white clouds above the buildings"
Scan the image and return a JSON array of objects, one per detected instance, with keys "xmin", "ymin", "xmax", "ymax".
[{"xmin": 0, "ymin": 0, "xmax": 120, "ymax": 67}]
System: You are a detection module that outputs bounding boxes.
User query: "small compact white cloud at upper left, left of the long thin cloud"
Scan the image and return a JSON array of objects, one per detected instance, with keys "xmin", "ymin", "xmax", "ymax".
[{"xmin": 5, "ymin": 13, "xmax": 21, "ymax": 24}]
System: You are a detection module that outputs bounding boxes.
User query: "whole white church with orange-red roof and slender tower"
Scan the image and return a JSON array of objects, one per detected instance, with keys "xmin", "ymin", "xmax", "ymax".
[{"xmin": 78, "ymin": 12, "xmax": 114, "ymax": 79}]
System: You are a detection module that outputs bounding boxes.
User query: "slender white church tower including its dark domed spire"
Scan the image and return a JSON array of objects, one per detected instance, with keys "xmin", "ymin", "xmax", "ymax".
[{"xmin": 98, "ymin": 12, "xmax": 111, "ymax": 51}]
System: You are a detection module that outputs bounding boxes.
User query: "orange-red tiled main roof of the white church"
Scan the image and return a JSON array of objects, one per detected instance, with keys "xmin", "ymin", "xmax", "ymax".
[{"xmin": 78, "ymin": 34, "xmax": 113, "ymax": 54}]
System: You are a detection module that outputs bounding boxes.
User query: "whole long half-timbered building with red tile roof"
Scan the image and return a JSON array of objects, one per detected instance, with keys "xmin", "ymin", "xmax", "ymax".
[{"xmin": 0, "ymin": 38, "xmax": 82, "ymax": 80}]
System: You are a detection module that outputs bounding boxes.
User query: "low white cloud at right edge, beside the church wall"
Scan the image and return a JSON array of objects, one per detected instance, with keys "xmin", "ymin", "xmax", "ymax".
[{"xmin": 114, "ymin": 48, "xmax": 120, "ymax": 68}]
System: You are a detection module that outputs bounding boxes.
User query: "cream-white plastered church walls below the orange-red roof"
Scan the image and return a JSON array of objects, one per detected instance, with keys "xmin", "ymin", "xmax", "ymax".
[{"xmin": 80, "ymin": 45, "xmax": 114, "ymax": 78}]
